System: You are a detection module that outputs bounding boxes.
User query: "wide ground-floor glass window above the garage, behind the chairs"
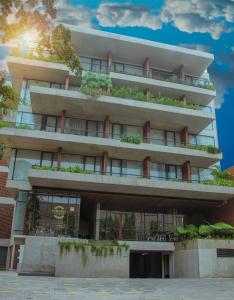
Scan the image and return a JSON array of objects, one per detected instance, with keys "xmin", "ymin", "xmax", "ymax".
[{"xmin": 99, "ymin": 210, "xmax": 183, "ymax": 241}]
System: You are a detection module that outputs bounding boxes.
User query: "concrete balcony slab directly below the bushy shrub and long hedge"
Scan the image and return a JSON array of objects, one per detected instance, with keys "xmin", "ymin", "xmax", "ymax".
[{"xmin": 30, "ymin": 86, "xmax": 214, "ymax": 134}]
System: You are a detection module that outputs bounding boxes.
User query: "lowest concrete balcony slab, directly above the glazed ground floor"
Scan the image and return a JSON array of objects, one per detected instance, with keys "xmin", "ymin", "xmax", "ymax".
[{"xmin": 29, "ymin": 169, "xmax": 234, "ymax": 201}]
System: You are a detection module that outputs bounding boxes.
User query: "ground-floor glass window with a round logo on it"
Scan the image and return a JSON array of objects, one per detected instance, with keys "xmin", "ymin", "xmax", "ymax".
[{"xmin": 27, "ymin": 193, "xmax": 80, "ymax": 237}]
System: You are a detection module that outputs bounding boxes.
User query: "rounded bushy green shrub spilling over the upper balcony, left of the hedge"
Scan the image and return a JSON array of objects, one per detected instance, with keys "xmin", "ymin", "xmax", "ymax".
[{"xmin": 80, "ymin": 72, "xmax": 112, "ymax": 96}]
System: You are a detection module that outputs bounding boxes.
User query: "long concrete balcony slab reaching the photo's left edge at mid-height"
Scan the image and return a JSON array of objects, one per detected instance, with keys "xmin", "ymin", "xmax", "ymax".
[{"xmin": 0, "ymin": 119, "xmax": 222, "ymax": 168}]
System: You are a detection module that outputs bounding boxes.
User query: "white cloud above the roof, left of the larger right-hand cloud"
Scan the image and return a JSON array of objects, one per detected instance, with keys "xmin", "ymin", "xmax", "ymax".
[{"xmin": 97, "ymin": 3, "xmax": 162, "ymax": 30}]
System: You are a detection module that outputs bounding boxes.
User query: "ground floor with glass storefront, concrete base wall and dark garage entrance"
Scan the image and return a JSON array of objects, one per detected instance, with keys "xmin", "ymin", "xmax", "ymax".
[{"xmin": 10, "ymin": 188, "xmax": 234, "ymax": 278}]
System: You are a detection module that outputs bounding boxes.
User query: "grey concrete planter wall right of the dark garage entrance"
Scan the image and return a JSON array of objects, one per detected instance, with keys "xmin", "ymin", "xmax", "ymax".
[{"xmin": 174, "ymin": 239, "xmax": 234, "ymax": 278}]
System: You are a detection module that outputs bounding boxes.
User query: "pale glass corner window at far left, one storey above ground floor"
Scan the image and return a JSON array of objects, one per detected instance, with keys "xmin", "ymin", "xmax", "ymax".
[{"xmin": 13, "ymin": 150, "xmax": 41, "ymax": 180}]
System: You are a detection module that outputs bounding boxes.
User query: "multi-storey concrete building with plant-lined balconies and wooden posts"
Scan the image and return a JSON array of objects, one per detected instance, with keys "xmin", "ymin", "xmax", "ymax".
[{"xmin": 0, "ymin": 26, "xmax": 234, "ymax": 277}]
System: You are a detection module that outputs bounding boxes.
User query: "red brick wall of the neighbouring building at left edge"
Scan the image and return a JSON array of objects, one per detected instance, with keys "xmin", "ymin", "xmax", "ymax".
[{"xmin": 0, "ymin": 160, "xmax": 14, "ymax": 239}]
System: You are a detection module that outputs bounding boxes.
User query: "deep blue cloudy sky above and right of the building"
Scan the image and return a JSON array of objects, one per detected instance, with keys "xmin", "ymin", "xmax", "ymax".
[{"xmin": 0, "ymin": 0, "xmax": 234, "ymax": 169}]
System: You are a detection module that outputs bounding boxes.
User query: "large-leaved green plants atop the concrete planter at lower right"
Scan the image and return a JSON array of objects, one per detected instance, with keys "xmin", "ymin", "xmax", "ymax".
[{"xmin": 175, "ymin": 223, "xmax": 234, "ymax": 240}]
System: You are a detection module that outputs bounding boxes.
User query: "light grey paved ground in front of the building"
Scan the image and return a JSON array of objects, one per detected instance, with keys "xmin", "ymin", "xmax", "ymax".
[{"xmin": 0, "ymin": 272, "xmax": 234, "ymax": 300}]
